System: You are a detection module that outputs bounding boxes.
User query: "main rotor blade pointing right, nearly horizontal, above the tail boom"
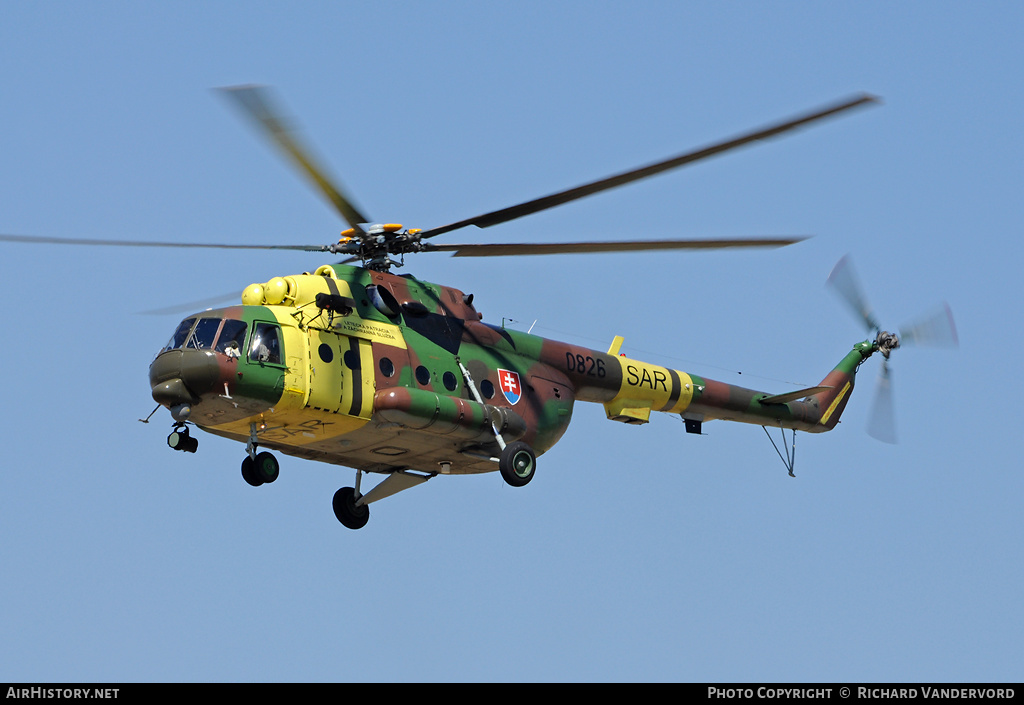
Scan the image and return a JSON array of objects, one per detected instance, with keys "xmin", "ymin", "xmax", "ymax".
[{"xmin": 423, "ymin": 238, "xmax": 806, "ymax": 257}]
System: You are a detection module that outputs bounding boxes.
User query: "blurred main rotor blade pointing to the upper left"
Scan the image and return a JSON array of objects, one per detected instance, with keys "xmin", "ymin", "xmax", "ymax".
[{"xmin": 220, "ymin": 86, "xmax": 370, "ymax": 231}]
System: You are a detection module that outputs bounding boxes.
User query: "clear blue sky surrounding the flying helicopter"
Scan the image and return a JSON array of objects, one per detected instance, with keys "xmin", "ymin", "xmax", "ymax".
[{"xmin": 0, "ymin": 2, "xmax": 1024, "ymax": 682}]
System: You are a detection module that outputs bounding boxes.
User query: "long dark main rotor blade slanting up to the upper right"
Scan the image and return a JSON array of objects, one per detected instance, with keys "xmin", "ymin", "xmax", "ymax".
[{"xmin": 420, "ymin": 93, "xmax": 878, "ymax": 239}]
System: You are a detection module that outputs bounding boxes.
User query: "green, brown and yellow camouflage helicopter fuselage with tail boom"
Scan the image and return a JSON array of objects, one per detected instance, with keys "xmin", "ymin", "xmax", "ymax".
[{"xmin": 150, "ymin": 264, "xmax": 873, "ymax": 473}]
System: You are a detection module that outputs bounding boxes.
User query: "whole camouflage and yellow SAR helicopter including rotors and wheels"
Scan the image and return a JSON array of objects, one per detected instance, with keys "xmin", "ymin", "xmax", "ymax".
[{"xmin": 0, "ymin": 85, "xmax": 955, "ymax": 529}]
